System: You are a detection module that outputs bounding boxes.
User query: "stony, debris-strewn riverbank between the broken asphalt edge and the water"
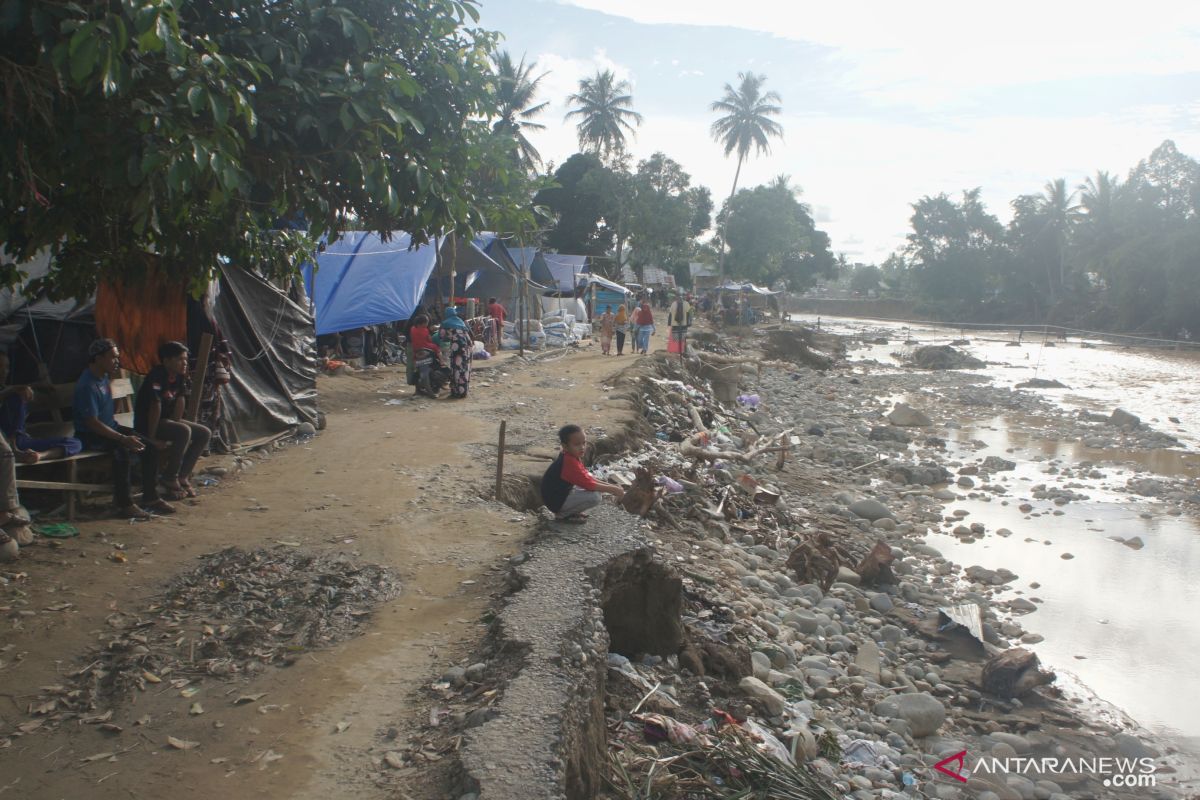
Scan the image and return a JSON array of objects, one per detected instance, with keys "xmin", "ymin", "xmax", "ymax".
[{"xmin": 585, "ymin": 328, "xmax": 1200, "ymax": 800}]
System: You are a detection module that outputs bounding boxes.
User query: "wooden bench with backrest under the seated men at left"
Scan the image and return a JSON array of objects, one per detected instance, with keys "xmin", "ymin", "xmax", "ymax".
[{"xmin": 17, "ymin": 378, "xmax": 133, "ymax": 519}]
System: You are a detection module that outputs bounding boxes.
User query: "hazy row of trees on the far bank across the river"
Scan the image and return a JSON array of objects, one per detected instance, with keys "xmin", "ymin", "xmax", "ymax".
[{"xmin": 886, "ymin": 140, "xmax": 1200, "ymax": 338}]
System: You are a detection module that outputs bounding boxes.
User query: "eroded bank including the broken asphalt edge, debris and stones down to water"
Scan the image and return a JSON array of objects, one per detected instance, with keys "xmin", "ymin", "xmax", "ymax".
[{"xmin": 422, "ymin": 321, "xmax": 1196, "ymax": 800}]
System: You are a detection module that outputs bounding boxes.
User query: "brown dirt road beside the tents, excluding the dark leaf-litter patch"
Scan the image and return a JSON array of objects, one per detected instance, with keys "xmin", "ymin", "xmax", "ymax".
[{"xmin": 0, "ymin": 342, "xmax": 664, "ymax": 800}]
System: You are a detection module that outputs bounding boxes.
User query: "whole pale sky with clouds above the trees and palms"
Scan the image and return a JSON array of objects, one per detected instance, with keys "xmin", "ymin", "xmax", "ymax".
[{"xmin": 481, "ymin": 0, "xmax": 1200, "ymax": 263}]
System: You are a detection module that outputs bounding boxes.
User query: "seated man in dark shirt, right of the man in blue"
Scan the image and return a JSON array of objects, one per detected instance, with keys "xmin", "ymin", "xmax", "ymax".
[{"xmin": 133, "ymin": 342, "xmax": 212, "ymax": 500}]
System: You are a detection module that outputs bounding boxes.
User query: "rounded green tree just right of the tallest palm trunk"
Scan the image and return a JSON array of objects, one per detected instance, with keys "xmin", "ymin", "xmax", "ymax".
[{"xmin": 718, "ymin": 181, "xmax": 836, "ymax": 291}]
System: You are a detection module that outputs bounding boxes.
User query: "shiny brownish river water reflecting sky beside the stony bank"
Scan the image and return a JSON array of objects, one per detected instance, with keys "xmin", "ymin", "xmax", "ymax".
[{"xmin": 793, "ymin": 315, "xmax": 1200, "ymax": 768}]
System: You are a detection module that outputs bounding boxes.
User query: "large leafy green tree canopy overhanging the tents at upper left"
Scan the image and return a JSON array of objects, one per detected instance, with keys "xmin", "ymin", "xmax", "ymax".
[{"xmin": 0, "ymin": 0, "xmax": 508, "ymax": 296}]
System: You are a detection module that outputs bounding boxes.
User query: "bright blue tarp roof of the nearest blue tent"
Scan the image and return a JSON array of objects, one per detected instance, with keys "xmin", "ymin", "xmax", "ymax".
[{"xmin": 304, "ymin": 230, "xmax": 437, "ymax": 335}]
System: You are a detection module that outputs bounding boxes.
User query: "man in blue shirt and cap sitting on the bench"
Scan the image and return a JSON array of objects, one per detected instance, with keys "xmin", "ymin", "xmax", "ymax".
[{"xmin": 73, "ymin": 339, "xmax": 175, "ymax": 519}]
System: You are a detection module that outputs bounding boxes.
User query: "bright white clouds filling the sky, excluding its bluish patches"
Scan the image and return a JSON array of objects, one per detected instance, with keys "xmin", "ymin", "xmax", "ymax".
[{"xmin": 535, "ymin": 0, "xmax": 1200, "ymax": 261}]
